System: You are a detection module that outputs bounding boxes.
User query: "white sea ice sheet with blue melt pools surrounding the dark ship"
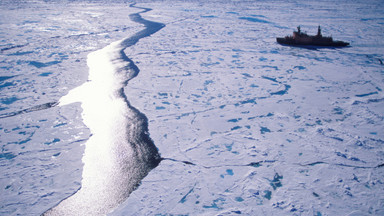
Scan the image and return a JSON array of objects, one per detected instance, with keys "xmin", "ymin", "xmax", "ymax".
[{"xmin": 0, "ymin": 0, "xmax": 384, "ymax": 215}]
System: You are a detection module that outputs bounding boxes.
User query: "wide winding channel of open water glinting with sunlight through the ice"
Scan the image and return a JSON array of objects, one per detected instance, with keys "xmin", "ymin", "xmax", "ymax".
[{"xmin": 44, "ymin": 4, "xmax": 165, "ymax": 215}]
